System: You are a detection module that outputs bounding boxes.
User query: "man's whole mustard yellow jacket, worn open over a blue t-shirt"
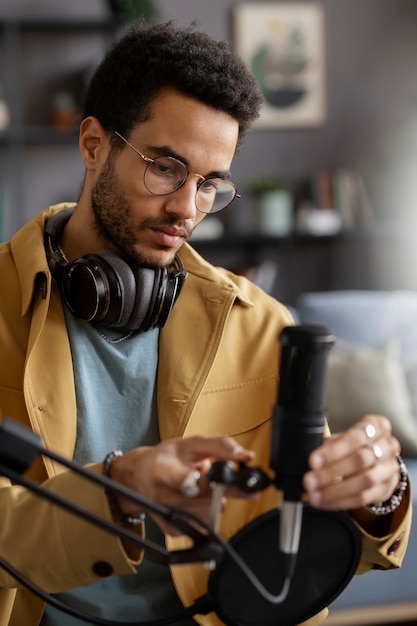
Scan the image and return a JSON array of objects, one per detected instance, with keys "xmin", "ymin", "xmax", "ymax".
[{"xmin": 0, "ymin": 205, "xmax": 411, "ymax": 626}]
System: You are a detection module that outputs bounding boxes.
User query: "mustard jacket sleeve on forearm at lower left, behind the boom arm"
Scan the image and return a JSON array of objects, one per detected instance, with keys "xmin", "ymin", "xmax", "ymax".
[{"xmin": 0, "ymin": 466, "xmax": 143, "ymax": 593}]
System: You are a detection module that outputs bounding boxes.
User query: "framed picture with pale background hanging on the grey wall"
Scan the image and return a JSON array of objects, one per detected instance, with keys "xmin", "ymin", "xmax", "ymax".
[{"xmin": 233, "ymin": 1, "xmax": 326, "ymax": 128}]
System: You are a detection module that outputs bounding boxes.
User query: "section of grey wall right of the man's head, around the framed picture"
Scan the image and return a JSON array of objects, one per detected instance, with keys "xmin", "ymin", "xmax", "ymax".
[{"xmin": 159, "ymin": 0, "xmax": 417, "ymax": 289}]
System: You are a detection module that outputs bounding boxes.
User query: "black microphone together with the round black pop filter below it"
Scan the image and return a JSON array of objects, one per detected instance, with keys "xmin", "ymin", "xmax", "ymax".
[{"xmin": 202, "ymin": 325, "xmax": 361, "ymax": 626}]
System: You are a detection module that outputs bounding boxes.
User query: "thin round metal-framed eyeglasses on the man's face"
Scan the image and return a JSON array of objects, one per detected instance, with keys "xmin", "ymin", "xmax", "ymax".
[{"xmin": 113, "ymin": 130, "xmax": 240, "ymax": 213}]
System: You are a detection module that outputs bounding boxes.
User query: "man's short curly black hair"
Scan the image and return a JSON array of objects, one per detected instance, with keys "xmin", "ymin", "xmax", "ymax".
[{"xmin": 83, "ymin": 21, "xmax": 262, "ymax": 147}]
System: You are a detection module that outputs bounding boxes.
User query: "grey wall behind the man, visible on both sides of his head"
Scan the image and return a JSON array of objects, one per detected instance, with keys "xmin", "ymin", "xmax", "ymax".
[{"xmin": 0, "ymin": 0, "xmax": 417, "ymax": 288}]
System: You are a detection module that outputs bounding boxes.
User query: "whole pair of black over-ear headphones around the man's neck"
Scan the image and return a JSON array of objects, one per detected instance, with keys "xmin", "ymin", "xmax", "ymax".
[{"xmin": 45, "ymin": 207, "xmax": 187, "ymax": 331}]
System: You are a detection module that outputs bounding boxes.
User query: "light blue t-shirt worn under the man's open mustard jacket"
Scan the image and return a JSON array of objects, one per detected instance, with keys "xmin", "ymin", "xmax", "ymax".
[{"xmin": 41, "ymin": 310, "xmax": 195, "ymax": 626}]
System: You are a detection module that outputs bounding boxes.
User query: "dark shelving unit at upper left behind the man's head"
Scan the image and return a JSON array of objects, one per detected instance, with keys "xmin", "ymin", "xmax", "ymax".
[{"xmin": 0, "ymin": 16, "xmax": 120, "ymax": 236}]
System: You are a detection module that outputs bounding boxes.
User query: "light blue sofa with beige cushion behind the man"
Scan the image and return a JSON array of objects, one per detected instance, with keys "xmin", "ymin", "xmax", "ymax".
[{"xmin": 294, "ymin": 290, "xmax": 417, "ymax": 626}]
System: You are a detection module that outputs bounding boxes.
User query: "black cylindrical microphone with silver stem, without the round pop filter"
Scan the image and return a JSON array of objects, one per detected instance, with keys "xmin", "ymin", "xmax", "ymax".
[{"xmin": 270, "ymin": 325, "xmax": 335, "ymax": 577}]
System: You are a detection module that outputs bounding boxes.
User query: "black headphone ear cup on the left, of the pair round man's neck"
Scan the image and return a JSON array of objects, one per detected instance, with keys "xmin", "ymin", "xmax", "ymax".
[{"xmin": 61, "ymin": 250, "xmax": 136, "ymax": 328}]
